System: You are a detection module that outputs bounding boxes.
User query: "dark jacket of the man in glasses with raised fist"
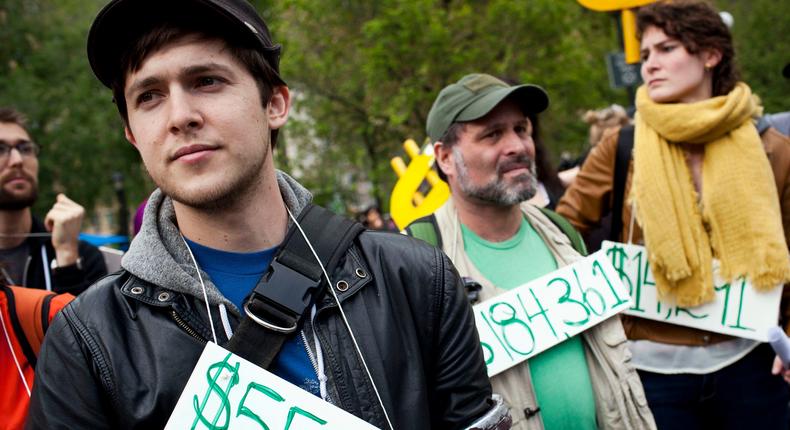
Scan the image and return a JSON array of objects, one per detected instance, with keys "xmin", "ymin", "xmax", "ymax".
[{"xmin": 22, "ymin": 217, "xmax": 107, "ymax": 295}]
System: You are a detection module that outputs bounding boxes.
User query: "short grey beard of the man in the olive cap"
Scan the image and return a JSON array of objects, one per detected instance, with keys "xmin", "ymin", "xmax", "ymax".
[{"xmin": 453, "ymin": 148, "xmax": 538, "ymax": 206}]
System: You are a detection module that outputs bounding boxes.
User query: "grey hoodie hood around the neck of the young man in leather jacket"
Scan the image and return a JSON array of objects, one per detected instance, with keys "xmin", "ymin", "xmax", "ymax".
[{"xmin": 121, "ymin": 170, "xmax": 312, "ymax": 315}]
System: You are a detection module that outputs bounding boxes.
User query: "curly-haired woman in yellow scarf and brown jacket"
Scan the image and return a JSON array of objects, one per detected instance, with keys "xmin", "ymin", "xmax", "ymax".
[{"xmin": 557, "ymin": 1, "xmax": 790, "ymax": 430}]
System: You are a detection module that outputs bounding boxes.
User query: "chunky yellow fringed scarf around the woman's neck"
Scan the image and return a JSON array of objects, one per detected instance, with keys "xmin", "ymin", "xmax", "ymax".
[{"xmin": 631, "ymin": 83, "xmax": 790, "ymax": 306}]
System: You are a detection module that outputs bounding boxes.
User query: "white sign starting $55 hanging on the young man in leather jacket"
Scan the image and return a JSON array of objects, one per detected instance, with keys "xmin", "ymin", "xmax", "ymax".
[{"xmin": 165, "ymin": 342, "xmax": 376, "ymax": 430}]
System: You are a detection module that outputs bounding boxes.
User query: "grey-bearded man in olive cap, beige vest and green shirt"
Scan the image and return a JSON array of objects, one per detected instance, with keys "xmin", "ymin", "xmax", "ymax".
[{"xmin": 406, "ymin": 74, "xmax": 655, "ymax": 430}]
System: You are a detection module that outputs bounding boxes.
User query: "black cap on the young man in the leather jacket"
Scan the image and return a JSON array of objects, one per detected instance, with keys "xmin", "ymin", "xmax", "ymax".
[{"xmin": 88, "ymin": 0, "xmax": 285, "ymax": 88}]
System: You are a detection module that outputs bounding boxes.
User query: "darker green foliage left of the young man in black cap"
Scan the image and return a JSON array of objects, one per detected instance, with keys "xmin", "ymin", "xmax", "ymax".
[{"xmin": 0, "ymin": 0, "xmax": 150, "ymax": 222}]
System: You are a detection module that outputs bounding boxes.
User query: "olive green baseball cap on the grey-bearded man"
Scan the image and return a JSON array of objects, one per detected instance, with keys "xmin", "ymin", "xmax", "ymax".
[{"xmin": 425, "ymin": 73, "xmax": 549, "ymax": 142}]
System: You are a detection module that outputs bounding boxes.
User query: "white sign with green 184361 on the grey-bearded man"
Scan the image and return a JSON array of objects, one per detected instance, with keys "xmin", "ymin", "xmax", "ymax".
[{"xmin": 474, "ymin": 252, "xmax": 631, "ymax": 376}]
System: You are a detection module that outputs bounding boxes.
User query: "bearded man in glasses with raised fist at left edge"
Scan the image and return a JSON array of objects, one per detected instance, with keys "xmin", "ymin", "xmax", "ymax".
[{"xmin": 0, "ymin": 107, "xmax": 107, "ymax": 295}]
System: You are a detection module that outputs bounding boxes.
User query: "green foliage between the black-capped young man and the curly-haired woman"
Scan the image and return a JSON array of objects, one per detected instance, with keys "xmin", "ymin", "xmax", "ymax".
[{"xmin": 274, "ymin": 0, "xmax": 618, "ymax": 208}]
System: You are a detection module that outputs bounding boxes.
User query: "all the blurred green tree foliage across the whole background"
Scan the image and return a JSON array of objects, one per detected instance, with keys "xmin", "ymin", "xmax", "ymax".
[{"xmin": 0, "ymin": 0, "xmax": 790, "ymax": 222}]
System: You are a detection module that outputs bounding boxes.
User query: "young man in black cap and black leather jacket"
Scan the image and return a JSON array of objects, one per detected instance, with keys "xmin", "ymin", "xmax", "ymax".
[{"xmin": 29, "ymin": 0, "xmax": 509, "ymax": 429}]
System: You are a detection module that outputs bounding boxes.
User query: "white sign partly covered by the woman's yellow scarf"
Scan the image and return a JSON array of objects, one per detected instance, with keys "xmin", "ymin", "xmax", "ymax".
[{"xmin": 601, "ymin": 241, "xmax": 782, "ymax": 342}]
